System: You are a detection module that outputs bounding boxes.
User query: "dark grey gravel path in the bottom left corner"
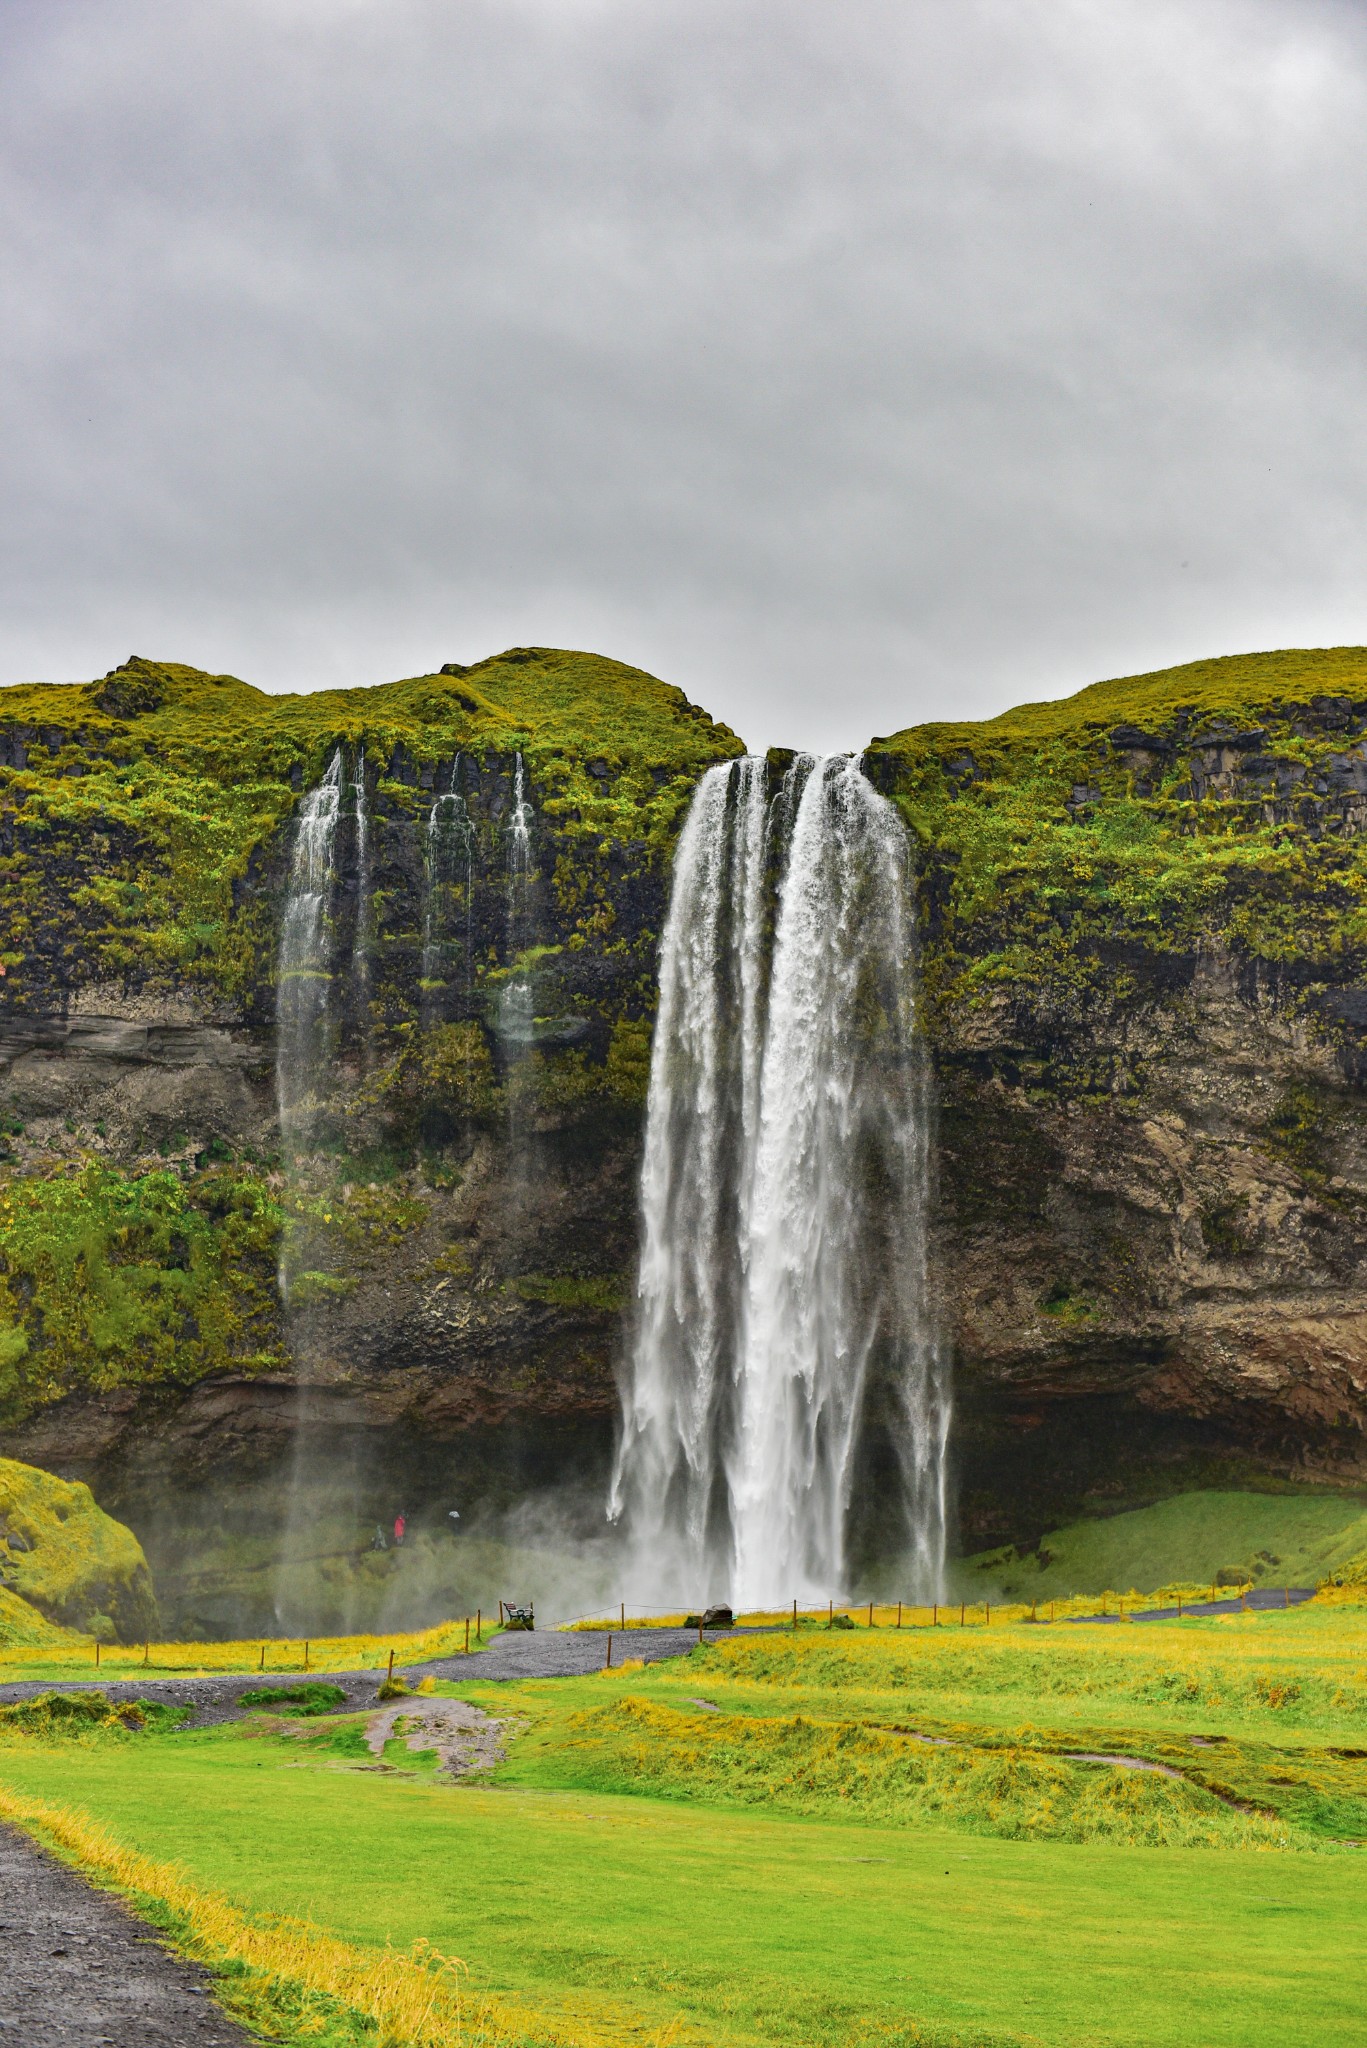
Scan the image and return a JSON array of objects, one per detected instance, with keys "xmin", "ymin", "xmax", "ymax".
[{"xmin": 0, "ymin": 1827, "xmax": 252, "ymax": 2048}]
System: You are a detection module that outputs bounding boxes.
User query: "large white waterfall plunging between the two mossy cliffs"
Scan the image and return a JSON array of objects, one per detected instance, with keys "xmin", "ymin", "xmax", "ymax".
[{"xmin": 611, "ymin": 756, "xmax": 949, "ymax": 1606}]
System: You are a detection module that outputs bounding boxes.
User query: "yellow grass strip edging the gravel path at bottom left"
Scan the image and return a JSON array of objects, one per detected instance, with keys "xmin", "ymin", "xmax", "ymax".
[{"xmin": 0, "ymin": 1786, "xmax": 660, "ymax": 2048}]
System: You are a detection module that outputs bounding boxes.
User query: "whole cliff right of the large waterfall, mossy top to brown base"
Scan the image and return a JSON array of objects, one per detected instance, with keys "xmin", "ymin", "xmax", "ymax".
[{"xmin": 869, "ymin": 647, "xmax": 1367, "ymax": 1536}]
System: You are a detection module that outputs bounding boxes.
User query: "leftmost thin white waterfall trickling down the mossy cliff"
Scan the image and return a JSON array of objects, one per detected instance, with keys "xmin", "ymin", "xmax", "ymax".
[{"xmin": 275, "ymin": 748, "xmax": 342, "ymax": 1147}]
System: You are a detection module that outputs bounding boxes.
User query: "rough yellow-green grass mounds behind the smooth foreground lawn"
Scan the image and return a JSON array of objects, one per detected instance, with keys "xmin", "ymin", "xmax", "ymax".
[{"xmin": 491, "ymin": 1602, "xmax": 1367, "ymax": 1849}]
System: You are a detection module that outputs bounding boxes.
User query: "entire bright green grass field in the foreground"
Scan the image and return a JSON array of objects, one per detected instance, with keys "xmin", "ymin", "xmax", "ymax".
[{"xmin": 0, "ymin": 1604, "xmax": 1367, "ymax": 2048}]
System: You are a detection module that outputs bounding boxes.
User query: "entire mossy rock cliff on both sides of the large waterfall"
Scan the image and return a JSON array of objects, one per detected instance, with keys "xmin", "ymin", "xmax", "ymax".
[{"xmin": 0, "ymin": 647, "xmax": 1367, "ymax": 1626}]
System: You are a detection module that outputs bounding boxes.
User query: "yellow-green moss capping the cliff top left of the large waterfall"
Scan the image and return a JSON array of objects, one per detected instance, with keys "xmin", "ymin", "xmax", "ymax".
[{"xmin": 0, "ymin": 647, "xmax": 740, "ymax": 999}]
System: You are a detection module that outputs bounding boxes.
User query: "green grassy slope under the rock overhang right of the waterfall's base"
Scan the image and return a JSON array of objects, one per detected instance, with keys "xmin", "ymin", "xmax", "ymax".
[{"xmin": 957, "ymin": 1489, "xmax": 1367, "ymax": 1606}]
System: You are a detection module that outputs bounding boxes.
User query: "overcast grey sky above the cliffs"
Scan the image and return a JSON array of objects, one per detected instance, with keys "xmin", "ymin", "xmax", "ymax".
[{"xmin": 0, "ymin": 0, "xmax": 1367, "ymax": 748}]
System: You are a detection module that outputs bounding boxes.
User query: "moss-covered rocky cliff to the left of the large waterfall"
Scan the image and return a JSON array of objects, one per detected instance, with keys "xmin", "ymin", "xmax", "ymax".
[{"xmin": 0, "ymin": 647, "xmax": 740, "ymax": 1493}]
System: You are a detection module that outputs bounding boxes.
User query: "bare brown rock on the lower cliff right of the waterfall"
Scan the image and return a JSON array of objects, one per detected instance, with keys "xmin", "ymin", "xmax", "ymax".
[{"xmin": 939, "ymin": 958, "xmax": 1367, "ymax": 1538}]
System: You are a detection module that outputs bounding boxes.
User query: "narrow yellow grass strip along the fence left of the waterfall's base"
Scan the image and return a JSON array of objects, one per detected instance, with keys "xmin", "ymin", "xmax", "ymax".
[{"xmin": 0, "ymin": 1618, "xmax": 475, "ymax": 1679}]
